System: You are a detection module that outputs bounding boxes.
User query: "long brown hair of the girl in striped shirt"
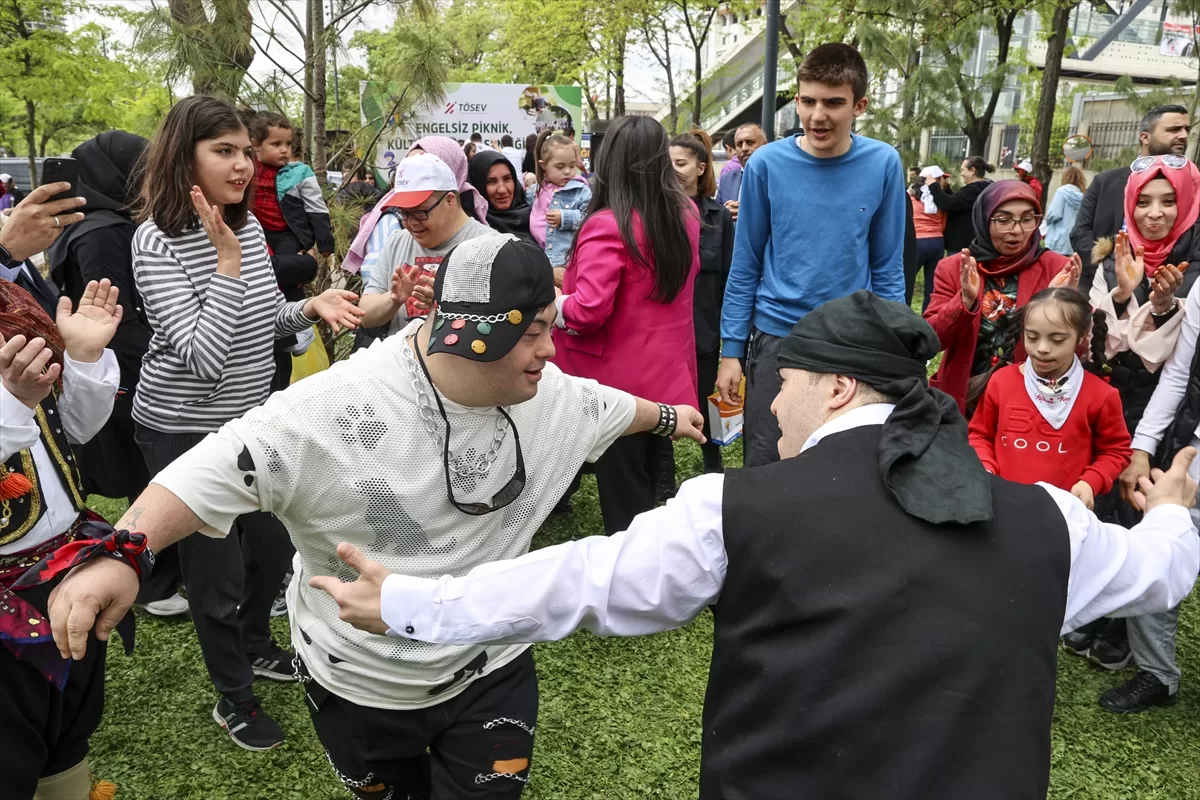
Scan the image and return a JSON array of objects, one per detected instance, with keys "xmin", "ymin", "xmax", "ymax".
[{"xmin": 133, "ymin": 95, "xmax": 253, "ymax": 236}]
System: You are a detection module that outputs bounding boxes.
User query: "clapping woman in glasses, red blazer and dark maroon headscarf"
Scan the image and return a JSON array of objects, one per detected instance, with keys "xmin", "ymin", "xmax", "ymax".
[{"xmin": 925, "ymin": 180, "xmax": 1081, "ymax": 416}]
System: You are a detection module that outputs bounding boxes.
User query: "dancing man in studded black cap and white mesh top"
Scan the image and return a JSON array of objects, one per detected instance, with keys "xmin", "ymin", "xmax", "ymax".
[{"xmin": 50, "ymin": 234, "xmax": 703, "ymax": 800}]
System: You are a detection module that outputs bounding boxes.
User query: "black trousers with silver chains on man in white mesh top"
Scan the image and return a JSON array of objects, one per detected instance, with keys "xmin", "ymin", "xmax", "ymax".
[{"xmin": 300, "ymin": 650, "xmax": 538, "ymax": 800}]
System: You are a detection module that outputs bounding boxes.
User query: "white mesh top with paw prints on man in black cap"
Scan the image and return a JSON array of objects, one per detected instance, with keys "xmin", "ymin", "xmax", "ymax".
[{"xmin": 154, "ymin": 321, "xmax": 635, "ymax": 709}]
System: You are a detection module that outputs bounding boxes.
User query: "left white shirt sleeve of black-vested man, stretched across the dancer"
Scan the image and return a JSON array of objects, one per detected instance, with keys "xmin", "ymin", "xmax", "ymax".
[{"xmin": 380, "ymin": 475, "xmax": 727, "ymax": 644}]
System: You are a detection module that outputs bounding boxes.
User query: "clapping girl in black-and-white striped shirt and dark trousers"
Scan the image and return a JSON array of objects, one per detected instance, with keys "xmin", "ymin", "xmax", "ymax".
[{"xmin": 133, "ymin": 97, "xmax": 362, "ymax": 751}]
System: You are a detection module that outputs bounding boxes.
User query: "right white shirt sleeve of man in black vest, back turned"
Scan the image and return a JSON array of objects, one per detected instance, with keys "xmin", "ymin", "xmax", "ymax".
[{"xmin": 1039, "ymin": 483, "xmax": 1200, "ymax": 633}]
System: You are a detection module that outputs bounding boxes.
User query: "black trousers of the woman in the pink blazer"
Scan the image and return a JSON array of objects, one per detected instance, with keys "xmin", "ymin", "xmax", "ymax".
[{"xmin": 593, "ymin": 433, "xmax": 671, "ymax": 535}]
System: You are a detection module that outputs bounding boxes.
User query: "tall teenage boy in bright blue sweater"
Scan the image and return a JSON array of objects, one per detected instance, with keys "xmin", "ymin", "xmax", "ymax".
[{"xmin": 716, "ymin": 43, "xmax": 907, "ymax": 467}]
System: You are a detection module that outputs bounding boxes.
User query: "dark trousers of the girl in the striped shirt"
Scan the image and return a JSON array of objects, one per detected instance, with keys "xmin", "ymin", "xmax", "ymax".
[{"xmin": 137, "ymin": 425, "xmax": 295, "ymax": 702}]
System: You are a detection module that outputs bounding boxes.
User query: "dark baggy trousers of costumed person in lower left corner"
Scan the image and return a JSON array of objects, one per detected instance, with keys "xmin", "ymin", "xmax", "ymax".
[{"xmin": 0, "ymin": 579, "xmax": 106, "ymax": 800}]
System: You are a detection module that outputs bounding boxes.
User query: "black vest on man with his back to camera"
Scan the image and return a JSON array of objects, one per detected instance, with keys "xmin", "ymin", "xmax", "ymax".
[{"xmin": 700, "ymin": 426, "xmax": 1070, "ymax": 800}]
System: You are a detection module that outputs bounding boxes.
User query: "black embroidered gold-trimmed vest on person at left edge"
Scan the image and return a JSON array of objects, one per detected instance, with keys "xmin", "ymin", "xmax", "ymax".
[{"xmin": 0, "ymin": 392, "xmax": 85, "ymax": 545}]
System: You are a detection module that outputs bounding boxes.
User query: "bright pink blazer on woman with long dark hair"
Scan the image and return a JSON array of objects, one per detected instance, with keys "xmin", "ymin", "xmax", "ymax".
[{"xmin": 553, "ymin": 208, "xmax": 700, "ymax": 405}]
